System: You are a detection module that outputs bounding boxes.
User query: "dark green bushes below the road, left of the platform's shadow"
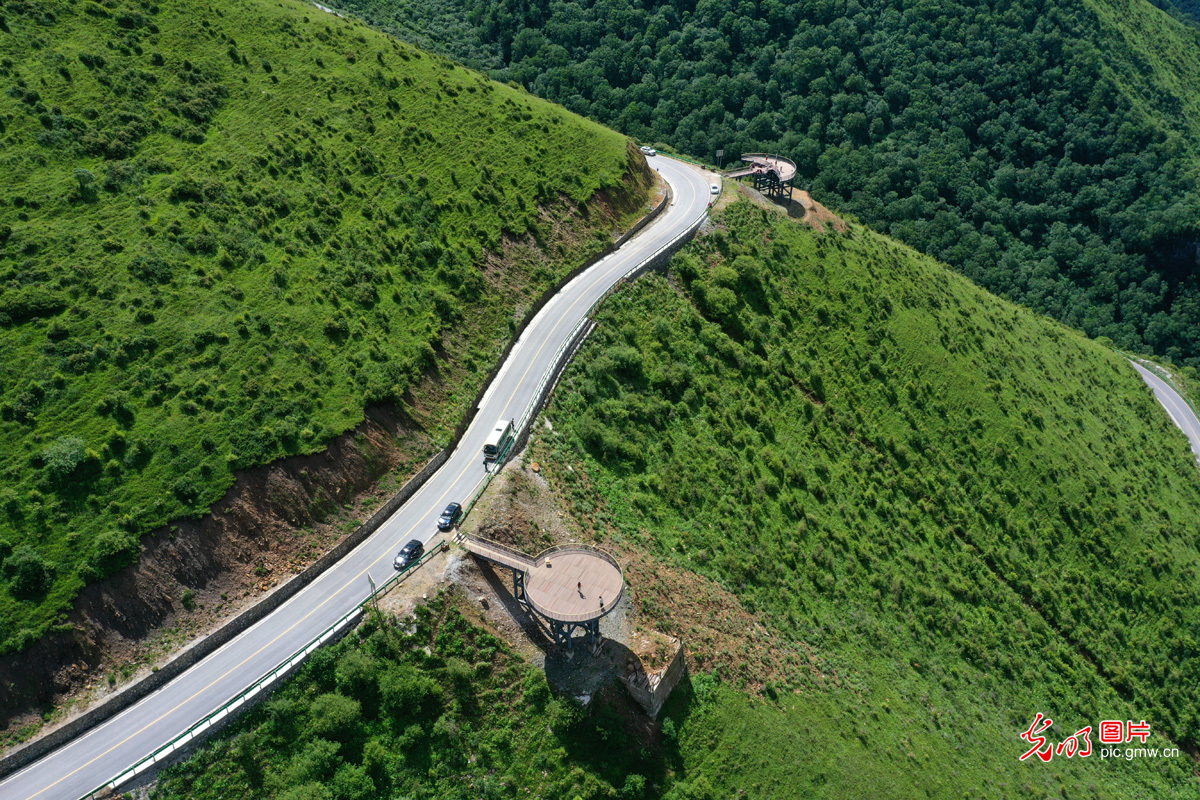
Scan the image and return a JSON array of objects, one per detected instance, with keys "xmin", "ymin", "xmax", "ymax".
[{"xmin": 154, "ymin": 596, "xmax": 665, "ymax": 800}]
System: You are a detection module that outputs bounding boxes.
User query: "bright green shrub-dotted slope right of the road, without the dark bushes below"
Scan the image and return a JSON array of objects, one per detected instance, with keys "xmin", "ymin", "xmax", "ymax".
[{"xmin": 535, "ymin": 203, "xmax": 1200, "ymax": 798}]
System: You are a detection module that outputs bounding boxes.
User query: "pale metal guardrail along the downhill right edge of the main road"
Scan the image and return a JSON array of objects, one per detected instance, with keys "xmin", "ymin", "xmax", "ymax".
[{"xmin": 80, "ymin": 163, "xmax": 708, "ymax": 800}]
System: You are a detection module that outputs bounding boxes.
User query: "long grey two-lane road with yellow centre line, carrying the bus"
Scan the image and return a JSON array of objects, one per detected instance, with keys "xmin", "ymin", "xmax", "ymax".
[{"xmin": 0, "ymin": 156, "xmax": 709, "ymax": 800}]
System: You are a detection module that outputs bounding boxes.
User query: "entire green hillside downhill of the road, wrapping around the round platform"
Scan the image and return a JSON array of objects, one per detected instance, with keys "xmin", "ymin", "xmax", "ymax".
[{"xmin": 145, "ymin": 204, "xmax": 1200, "ymax": 800}]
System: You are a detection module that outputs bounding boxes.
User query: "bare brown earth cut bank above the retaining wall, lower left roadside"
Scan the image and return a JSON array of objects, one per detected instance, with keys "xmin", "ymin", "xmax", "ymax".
[{"xmin": 0, "ymin": 408, "xmax": 434, "ymax": 743}]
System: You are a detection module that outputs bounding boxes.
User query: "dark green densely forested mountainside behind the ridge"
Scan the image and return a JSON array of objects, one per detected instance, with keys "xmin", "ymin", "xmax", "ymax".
[{"xmin": 341, "ymin": 0, "xmax": 1200, "ymax": 365}]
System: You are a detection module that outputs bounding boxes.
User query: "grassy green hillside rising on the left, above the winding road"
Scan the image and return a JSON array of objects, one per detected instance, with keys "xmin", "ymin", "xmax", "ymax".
[{"xmin": 0, "ymin": 0, "xmax": 649, "ymax": 651}]
